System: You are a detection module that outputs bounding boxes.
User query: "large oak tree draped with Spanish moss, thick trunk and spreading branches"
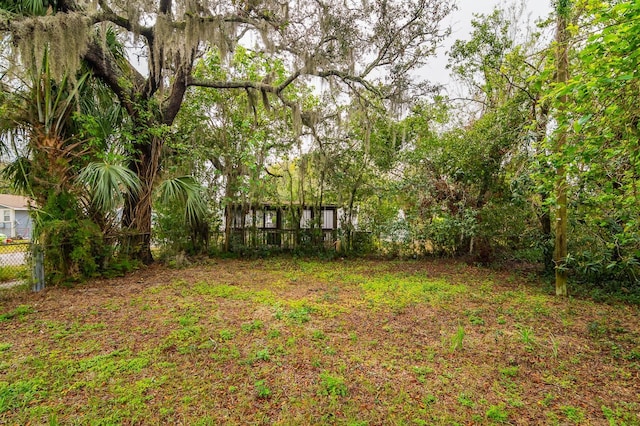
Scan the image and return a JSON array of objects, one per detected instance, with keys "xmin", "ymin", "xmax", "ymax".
[{"xmin": 0, "ymin": 0, "xmax": 452, "ymax": 262}]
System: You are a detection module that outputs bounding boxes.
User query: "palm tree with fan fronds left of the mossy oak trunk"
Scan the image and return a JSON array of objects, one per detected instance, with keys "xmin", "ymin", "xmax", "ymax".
[{"xmin": 0, "ymin": 55, "xmax": 205, "ymax": 282}]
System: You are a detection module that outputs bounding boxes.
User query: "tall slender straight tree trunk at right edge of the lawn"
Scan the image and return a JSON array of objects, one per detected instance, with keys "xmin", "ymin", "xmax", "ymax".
[{"xmin": 553, "ymin": 0, "xmax": 571, "ymax": 296}]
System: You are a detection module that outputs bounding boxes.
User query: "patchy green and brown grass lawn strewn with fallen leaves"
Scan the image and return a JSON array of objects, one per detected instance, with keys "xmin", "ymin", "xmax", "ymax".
[{"xmin": 0, "ymin": 259, "xmax": 640, "ymax": 425}]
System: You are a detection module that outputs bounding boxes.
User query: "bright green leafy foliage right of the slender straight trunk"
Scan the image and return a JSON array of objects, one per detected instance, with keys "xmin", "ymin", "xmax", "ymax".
[{"xmin": 549, "ymin": 1, "xmax": 640, "ymax": 293}]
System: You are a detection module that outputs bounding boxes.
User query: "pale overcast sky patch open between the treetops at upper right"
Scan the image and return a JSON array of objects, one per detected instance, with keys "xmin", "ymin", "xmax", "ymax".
[{"xmin": 421, "ymin": 0, "xmax": 552, "ymax": 87}]
